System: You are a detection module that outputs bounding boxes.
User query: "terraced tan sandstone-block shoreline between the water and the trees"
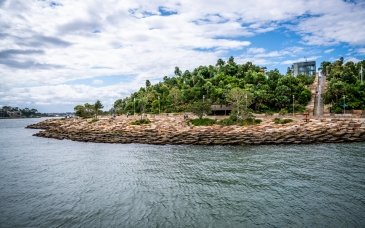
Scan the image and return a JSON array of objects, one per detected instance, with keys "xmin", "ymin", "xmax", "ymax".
[{"xmin": 27, "ymin": 115, "xmax": 365, "ymax": 145}]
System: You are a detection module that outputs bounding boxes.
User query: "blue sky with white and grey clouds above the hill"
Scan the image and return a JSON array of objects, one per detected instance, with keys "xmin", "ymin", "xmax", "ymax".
[{"xmin": 0, "ymin": 0, "xmax": 365, "ymax": 112}]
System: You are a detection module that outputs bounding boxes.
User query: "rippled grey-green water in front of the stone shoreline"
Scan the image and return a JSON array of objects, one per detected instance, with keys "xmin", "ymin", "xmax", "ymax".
[{"xmin": 0, "ymin": 119, "xmax": 365, "ymax": 227}]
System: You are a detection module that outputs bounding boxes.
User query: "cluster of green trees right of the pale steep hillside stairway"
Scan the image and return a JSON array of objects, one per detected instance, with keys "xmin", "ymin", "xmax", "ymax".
[{"xmin": 321, "ymin": 58, "xmax": 365, "ymax": 113}]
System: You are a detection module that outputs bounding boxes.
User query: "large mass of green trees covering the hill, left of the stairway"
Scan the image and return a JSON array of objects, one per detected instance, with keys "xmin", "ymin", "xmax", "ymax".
[{"xmin": 114, "ymin": 57, "xmax": 314, "ymax": 118}]
